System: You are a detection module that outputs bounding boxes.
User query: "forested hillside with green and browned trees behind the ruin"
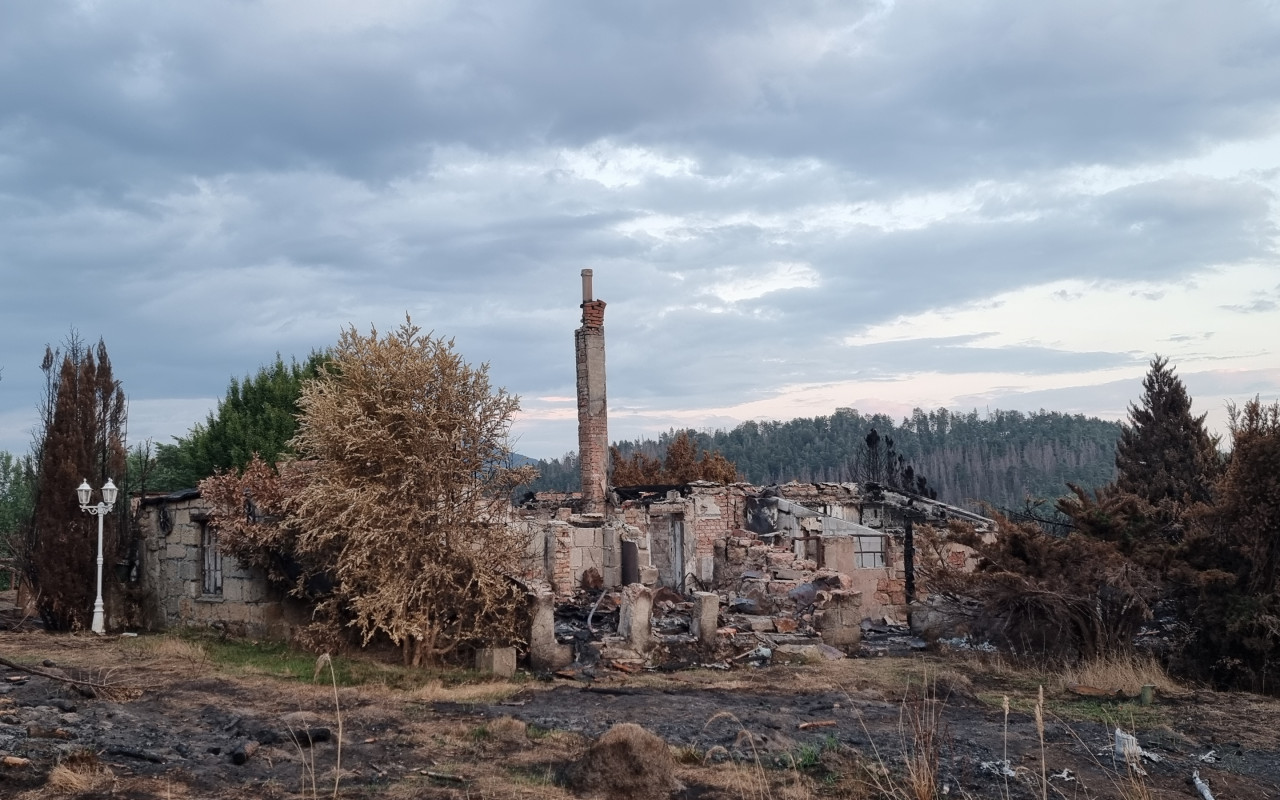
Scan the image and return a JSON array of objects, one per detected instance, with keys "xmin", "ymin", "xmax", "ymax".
[{"xmin": 524, "ymin": 408, "xmax": 1120, "ymax": 508}]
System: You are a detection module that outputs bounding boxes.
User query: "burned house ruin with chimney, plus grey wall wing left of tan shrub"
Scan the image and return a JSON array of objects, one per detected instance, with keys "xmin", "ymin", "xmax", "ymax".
[{"xmin": 129, "ymin": 270, "xmax": 995, "ymax": 664}]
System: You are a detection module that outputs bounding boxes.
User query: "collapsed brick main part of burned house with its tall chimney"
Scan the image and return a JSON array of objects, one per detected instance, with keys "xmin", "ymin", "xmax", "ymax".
[{"xmin": 509, "ymin": 270, "xmax": 995, "ymax": 665}]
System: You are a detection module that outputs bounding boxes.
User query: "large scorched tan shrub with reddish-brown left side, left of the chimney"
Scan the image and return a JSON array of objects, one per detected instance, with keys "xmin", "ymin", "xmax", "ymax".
[{"xmin": 201, "ymin": 319, "xmax": 535, "ymax": 666}]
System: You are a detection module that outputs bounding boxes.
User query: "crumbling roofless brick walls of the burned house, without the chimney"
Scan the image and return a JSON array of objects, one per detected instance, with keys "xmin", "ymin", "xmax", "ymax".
[{"xmin": 517, "ymin": 483, "xmax": 991, "ymax": 622}]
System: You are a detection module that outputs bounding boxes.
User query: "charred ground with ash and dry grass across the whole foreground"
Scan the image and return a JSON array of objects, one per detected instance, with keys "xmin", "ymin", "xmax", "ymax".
[{"xmin": 0, "ymin": 631, "xmax": 1280, "ymax": 800}]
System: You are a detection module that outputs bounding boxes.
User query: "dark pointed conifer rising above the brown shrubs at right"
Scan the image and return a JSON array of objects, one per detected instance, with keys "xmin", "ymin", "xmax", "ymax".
[{"xmin": 1116, "ymin": 356, "xmax": 1220, "ymax": 506}]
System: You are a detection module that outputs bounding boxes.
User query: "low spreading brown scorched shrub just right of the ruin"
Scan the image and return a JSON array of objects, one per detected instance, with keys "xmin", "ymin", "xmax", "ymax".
[{"xmin": 919, "ymin": 520, "xmax": 1155, "ymax": 662}]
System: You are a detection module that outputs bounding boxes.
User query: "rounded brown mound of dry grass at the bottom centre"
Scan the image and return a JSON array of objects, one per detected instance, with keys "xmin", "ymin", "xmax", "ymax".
[{"xmin": 566, "ymin": 722, "xmax": 684, "ymax": 800}]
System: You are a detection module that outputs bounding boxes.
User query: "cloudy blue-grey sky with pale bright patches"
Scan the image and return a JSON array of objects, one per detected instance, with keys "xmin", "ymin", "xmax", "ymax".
[{"xmin": 0, "ymin": 0, "xmax": 1280, "ymax": 457}]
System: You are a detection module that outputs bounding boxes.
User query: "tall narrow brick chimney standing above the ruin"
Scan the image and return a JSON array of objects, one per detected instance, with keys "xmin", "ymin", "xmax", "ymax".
[{"xmin": 573, "ymin": 270, "xmax": 609, "ymax": 513}]
